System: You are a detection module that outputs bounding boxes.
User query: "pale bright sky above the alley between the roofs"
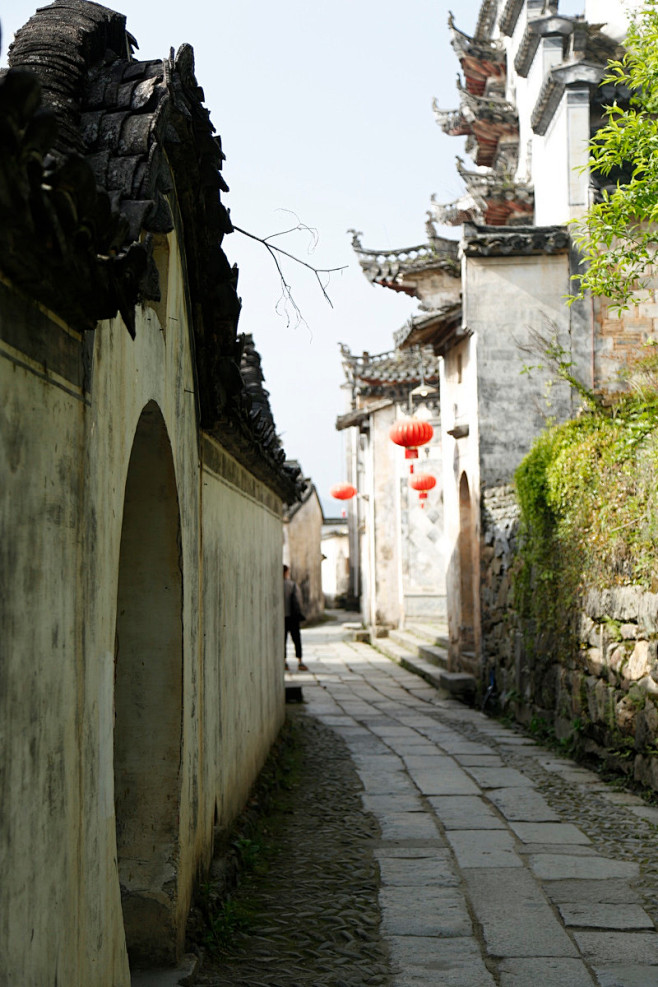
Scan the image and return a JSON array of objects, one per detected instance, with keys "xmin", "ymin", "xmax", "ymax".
[{"xmin": 0, "ymin": 0, "xmax": 482, "ymax": 517}]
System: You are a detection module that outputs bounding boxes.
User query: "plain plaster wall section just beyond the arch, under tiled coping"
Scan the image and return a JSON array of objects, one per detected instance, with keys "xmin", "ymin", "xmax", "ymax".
[{"xmin": 202, "ymin": 446, "xmax": 284, "ymax": 827}]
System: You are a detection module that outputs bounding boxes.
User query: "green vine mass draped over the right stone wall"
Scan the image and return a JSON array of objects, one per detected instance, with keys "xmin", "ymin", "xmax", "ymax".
[{"xmin": 514, "ymin": 346, "xmax": 658, "ymax": 660}]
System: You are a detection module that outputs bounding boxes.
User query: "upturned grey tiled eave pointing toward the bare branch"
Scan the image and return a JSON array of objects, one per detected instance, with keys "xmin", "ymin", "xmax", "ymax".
[{"xmin": 349, "ymin": 230, "xmax": 460, "ymax": 295}]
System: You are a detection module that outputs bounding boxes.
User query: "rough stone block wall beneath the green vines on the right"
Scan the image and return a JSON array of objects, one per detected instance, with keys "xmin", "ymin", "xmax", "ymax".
[{"xmin": 480, "ymin": 486, "xmax": 658, "ymax": 790}]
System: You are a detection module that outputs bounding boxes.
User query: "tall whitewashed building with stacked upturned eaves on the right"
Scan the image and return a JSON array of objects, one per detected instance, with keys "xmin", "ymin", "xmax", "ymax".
[{"xmin": 346, "ymin": 0, "xmax": 654, "ymax": 681}]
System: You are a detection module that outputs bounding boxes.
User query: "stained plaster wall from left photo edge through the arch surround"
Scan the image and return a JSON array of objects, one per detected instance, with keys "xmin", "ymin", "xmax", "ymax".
[{"xmin": 0, "ymin": 270, "xmax": 201, "ymax": 987}]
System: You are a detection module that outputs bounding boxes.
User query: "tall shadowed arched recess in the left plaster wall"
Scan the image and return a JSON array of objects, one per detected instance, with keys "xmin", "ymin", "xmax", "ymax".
[{"xmin": 114, "ymin": 401, "xmax": 183, "ymax": 966}]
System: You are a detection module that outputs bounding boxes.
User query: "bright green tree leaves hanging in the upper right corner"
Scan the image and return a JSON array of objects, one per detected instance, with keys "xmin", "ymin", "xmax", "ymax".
[{"xmin": 571, "ymin": 0, "xmax": 658, "ymax": 309}]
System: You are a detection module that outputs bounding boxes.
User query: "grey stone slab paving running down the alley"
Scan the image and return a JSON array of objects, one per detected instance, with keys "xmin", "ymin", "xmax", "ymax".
[{"xmin": 192, "ymin": 625, "xmax": 658, "ymax": 987}]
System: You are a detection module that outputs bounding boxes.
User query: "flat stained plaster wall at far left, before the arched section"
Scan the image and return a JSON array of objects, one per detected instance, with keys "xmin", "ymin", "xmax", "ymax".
[{"xmin": 0, "ymin": 328, "xmax": 87, "ymax": 987}]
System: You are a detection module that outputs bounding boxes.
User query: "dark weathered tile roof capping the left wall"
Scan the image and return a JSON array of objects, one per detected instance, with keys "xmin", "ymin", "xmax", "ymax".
[{"xmin": 0, "ymin": 0, "xmax": 299, "ymax": 499}]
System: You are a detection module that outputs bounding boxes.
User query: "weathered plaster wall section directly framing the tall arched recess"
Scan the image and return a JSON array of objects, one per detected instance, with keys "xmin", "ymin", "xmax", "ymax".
[{"xmin": 79, "ymin": 235, "xmax": 201, "ymax": 985}]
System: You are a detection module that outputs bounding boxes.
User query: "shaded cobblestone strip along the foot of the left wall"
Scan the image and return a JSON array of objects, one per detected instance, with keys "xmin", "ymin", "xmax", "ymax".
[{"xmin": 198, "ymin": 707, "xmax": 391, "ymax": 987}]
